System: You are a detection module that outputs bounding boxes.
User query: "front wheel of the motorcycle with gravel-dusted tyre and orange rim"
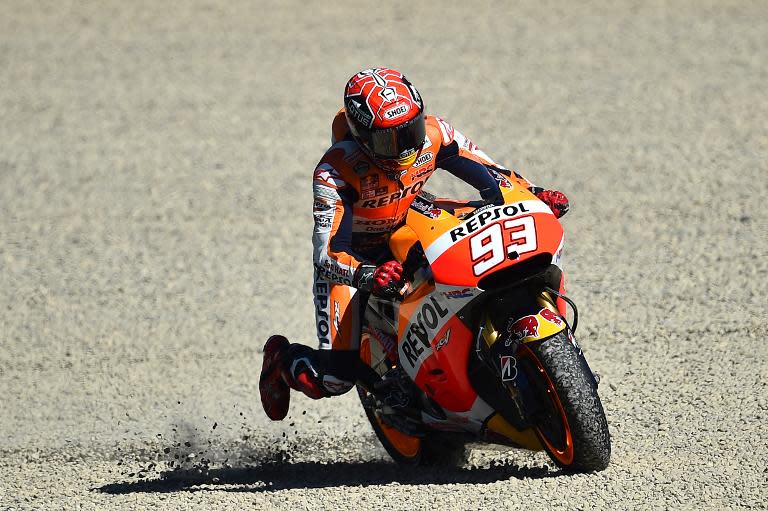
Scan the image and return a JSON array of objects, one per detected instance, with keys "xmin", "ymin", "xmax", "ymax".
[{"xmin": 518, "ymin": 331, "xmax": 611, "ymax": 472}]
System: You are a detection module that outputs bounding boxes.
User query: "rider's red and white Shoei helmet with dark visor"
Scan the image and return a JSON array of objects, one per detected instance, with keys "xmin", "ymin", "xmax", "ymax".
[{"xmin": 344, "ymin": 67, "xmax": 426, "ymax": 176}]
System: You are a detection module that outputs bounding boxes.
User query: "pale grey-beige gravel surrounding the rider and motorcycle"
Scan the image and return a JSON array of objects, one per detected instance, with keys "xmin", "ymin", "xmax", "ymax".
[{"xmin": 0, "ymin": 0, "xmax": 768, "ymax": 510}]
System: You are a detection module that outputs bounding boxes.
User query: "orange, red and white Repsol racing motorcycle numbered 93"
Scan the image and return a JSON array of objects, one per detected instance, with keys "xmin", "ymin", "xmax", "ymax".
[{"xmin": 357, "ymin": 176, "xmax": 611, "ymax": 472}]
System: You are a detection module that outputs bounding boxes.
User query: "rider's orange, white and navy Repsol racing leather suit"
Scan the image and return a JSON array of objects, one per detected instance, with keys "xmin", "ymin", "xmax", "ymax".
[{"xmin": 300, "ymin": 109, "xmax": 531, "ymax": 397}]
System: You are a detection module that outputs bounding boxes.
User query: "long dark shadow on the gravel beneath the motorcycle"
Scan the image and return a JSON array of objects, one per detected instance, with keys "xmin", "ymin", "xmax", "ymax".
[{"xmin": 94, "ymin": 461, "xmax": 559, "ymax": 495}]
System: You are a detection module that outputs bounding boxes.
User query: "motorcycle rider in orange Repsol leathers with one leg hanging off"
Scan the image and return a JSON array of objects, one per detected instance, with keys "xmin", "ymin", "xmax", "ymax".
[{"xmin": 259, "ymin": 68, "xmax": 568, "ymax": 420}]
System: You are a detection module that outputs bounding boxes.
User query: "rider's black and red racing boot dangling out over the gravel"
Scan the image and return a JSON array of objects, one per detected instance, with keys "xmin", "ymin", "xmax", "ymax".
[{"xmin": 259, "ymin": 335, "xmax": 329, "ymax": 421}]
